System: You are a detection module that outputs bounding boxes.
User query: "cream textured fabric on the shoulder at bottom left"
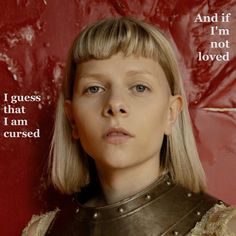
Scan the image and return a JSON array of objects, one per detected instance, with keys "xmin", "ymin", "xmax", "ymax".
[{"xmin": 22, "ymin": 209, "xmax": 59, "ymax": 236}]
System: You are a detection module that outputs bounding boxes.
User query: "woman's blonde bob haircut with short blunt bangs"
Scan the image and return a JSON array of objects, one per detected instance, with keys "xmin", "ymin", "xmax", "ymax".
[{"xmin": 49, "ymin": 17, "xmax": 206, "ymax": 194}]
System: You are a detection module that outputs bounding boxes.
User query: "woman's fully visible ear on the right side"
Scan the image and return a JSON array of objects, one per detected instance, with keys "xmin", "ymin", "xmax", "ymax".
[{"xmin": 164, "ymin": 95, "xmax": 183, "ymax": 135}]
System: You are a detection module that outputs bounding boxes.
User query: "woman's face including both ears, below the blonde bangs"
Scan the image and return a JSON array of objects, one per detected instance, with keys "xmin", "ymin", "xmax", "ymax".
[{"xmin": 65, "ymin": 53, "xmax": 181, "ymax": 169}]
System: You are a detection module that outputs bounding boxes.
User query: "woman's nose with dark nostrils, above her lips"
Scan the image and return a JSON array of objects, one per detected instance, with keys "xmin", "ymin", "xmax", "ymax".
[{"xmin": 103, "ymin": 90, "xmax": 129, "ymax": 117}]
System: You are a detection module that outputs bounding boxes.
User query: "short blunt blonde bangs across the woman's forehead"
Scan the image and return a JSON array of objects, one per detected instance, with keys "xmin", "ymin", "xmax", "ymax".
[{"xmin": 73, "ymin": 18, "xmax": 160, "ymax": 63}]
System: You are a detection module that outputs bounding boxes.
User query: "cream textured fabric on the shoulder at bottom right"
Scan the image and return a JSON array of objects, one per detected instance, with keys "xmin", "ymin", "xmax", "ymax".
[{"xmin": 190, "ymin": 204, "xmax": 236, "ymax": 236}]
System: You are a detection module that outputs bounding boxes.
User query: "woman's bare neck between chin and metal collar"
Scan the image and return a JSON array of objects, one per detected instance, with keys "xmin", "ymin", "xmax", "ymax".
[{"xmin": 96, "ymin": 158, "xmax": 160, "ymax": 204}]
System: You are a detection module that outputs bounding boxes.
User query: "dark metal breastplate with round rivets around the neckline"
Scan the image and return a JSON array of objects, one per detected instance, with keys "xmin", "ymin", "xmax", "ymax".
[{"xmin": 46, "ymin": 175, "xmax": 217, "ymax": 236}]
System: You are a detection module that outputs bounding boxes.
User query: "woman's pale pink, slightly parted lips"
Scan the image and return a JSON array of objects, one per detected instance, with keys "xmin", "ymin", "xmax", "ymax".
[{"xmin": 103, "ymin": 128, "xmax": 134, "ymax": 145}]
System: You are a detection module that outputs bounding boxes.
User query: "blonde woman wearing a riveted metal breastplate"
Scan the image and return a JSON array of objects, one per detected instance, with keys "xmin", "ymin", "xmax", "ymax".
[{"xmin": 23, "ymin": 18, "xmax": 236, "ymax": 236}]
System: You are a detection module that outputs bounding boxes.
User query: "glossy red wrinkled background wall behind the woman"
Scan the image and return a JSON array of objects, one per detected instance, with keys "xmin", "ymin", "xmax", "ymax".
[{"xmin": 0, "ymin": 0, "xmax": 236, "ymax": 236}]
